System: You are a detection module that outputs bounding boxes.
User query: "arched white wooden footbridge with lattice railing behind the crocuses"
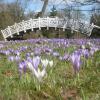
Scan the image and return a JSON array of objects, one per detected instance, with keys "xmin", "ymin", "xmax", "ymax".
[{"xmin": 1, "ymin": 17, "xmax": 100, "ymax": 40}]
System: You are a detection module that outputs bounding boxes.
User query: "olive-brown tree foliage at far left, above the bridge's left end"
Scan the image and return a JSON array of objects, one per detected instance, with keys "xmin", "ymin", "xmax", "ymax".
[{"xmin": 0, "ymin": 0, "xmax": 24, "ymax": 29}]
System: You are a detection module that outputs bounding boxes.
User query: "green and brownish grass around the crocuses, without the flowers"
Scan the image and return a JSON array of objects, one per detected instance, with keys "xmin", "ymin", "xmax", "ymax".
[{"xmin": 0, "ymin": 39, "xmax": 100, "ymax": 100}]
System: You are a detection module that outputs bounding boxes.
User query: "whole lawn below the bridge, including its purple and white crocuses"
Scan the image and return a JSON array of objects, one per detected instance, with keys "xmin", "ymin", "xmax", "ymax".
[{"xmin": 0, "ymin": 39, "xmax": 100, "ymax": 100}]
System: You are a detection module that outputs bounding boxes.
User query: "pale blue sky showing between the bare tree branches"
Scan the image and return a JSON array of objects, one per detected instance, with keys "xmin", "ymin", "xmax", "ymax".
[{"xmin": 3, "ymin": 0, "xmax": 97, "ymax": 18}]
